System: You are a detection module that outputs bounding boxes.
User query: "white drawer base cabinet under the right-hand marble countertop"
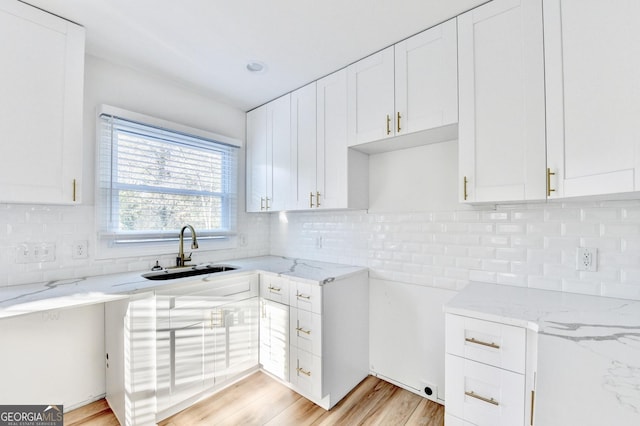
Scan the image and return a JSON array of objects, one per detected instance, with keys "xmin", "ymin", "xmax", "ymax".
[{"xmin": 445, "ymin": 314, "xmax": 535, "ymax": 426}]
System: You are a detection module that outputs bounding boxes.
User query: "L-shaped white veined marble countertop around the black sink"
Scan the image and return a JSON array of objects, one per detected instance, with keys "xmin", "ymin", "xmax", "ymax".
[{"xmin": 0, "ymin": 256, "xmax": 366, "ymax": 318}]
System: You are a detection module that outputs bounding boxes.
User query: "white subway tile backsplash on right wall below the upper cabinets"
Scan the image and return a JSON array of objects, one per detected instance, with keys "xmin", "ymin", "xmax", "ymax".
[{"xmin": 271, "ymin": 200, "xmax": 640, "ymax": 299}]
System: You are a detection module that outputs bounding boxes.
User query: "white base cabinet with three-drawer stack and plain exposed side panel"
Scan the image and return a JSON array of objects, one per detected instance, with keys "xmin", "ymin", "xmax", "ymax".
[{"xmin": 260, "ymin": 271, "xmax": 369, "ymax": 410}]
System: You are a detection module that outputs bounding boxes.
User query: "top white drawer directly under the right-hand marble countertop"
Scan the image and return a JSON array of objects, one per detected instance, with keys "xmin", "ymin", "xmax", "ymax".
[{"xmin": 446, "ymin": 314, "xmax": 526, "ymax": 373}]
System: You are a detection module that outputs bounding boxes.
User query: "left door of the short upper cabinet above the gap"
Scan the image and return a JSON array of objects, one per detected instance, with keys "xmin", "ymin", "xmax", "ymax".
[{"xmin": 347, "ymin": 46, "xmax": 395, "ymax": 146}]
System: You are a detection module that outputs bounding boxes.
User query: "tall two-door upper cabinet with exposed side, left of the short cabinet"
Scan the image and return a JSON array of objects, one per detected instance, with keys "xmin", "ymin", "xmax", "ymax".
[{"xmin": 291, "ymin": 69, "xmax": 369, "ymax": 210}]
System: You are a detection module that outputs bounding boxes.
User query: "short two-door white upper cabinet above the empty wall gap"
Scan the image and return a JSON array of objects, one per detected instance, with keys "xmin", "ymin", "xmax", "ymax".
[{"xmin": 347, "ymin": 19, "xmax": 458, "ymax": 152}]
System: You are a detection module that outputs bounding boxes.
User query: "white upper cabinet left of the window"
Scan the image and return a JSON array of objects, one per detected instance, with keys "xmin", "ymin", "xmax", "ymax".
[{"xmin": 0, "ymin": 0, "xmax": 85, "ymax": 204}]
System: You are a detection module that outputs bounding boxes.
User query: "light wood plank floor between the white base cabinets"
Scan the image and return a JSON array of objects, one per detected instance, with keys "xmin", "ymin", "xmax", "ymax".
[{"xmin": 64, "ymin": 372, "xmax": 444, "ymax": 426}]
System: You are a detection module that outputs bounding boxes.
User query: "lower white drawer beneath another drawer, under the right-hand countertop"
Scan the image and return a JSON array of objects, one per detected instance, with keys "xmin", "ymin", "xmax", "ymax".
[{"xmin": 445, "ymin": 354, "xmax": 525, "ymax": 426}]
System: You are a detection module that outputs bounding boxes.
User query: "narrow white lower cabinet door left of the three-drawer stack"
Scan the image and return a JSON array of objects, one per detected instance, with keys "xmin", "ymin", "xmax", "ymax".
[{"xmin": 260, "ymin": 299, "xmax": 289, "ymax": 381}]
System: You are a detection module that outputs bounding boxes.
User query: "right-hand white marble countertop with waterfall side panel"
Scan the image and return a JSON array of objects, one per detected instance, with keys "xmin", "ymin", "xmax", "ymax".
[{"xmin": 444, "ymin": 283, "xmax": 640, "ymax": 426}]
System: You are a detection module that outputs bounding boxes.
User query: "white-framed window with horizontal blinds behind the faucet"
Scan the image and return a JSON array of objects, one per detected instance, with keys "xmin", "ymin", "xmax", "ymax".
[{"xmin": 97, "ymin": 106, "xmax": 238, "ymax": 251}]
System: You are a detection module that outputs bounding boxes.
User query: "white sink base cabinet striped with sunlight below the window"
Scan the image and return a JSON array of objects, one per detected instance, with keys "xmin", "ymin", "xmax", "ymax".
[{"xmin": 105, "ymin": 274, "xmax": 258, "ymax": 425}]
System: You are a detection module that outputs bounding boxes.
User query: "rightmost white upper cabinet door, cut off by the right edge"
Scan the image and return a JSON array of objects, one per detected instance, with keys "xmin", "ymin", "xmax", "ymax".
[{"xmin": 544, "ymin": 0, "xmax": 640, "ymax": 197}]
